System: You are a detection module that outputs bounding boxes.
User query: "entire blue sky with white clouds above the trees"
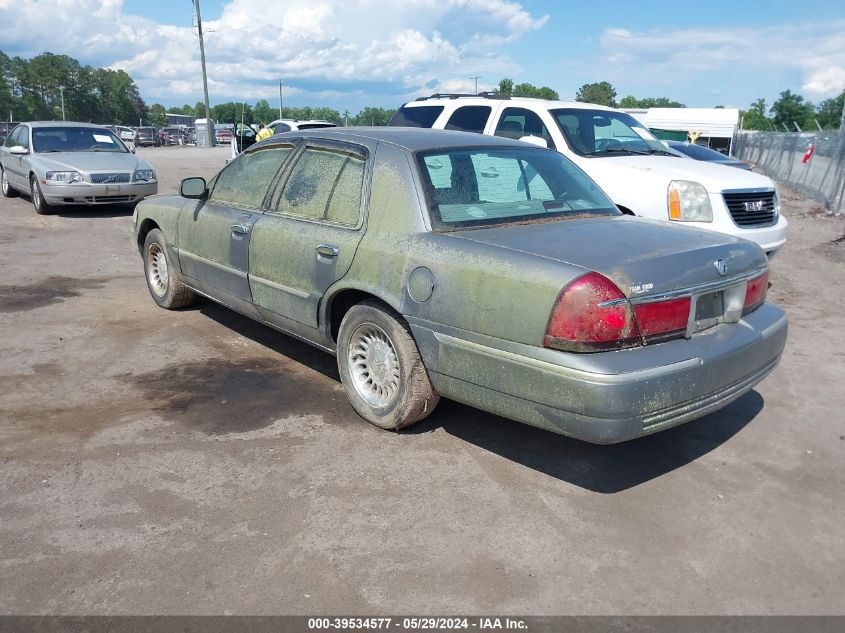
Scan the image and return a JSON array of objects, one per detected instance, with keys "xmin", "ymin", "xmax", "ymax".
[{"xmin": 0, "ymin": 0, "xmax": 845, "ymax": 113}]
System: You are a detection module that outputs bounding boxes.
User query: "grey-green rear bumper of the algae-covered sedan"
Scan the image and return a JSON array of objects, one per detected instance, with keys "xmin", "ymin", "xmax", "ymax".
[{"xmin": 409, "ymin": 304, "xmax": 787, "ymax": 444}]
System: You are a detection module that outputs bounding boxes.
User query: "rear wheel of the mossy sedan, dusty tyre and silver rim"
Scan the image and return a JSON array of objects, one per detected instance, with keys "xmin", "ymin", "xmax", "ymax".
[{"xmin": 337, "ymin": 301, "xmax": 440, "ymax": 429}]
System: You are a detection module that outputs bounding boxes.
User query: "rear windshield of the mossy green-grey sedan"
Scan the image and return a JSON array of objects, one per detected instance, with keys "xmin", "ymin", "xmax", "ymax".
[{"xmin": 417, "ymin": 146, "xmax": 619, "ymax": 230}]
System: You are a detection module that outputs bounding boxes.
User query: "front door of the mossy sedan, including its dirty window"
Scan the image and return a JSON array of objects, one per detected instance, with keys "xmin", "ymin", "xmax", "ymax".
[{"xmin": 178, "ymin": 144, "xmax": 294, "ymax": 315}]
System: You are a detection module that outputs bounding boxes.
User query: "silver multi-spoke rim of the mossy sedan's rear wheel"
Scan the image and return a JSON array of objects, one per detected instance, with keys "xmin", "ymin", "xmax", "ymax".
[{"xmin": 346, "ymin": 323, "xmax": 401, "ymax": 408}]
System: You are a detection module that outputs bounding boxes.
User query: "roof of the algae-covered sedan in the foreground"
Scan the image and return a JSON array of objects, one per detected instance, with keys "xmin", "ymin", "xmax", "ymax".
[{"xmin": 261, "ymin": 126, "xmax": 526, "ymax": 152}]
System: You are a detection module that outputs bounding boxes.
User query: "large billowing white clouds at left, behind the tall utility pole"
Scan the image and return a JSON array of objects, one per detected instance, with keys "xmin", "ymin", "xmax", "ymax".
[{"xmin": 0, "ymin": 0, "xmax": 548, "ymax": 102}]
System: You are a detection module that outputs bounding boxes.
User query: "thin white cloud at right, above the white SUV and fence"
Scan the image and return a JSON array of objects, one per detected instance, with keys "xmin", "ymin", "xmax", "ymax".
[{"xmin": 597, "ymin": 21, "xmax": 845, "ymax": 100}]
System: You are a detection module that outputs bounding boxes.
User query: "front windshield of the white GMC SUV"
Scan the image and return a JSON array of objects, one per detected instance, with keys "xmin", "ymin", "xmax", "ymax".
[{"xmin": 551, "ymin": 108, "xmax": 675, "ymax": 156}]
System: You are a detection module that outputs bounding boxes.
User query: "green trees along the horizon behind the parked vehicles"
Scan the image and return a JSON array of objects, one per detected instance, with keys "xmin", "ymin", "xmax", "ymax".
[{"xmin": 0, "ymin": 51, "xmax": 845, "ymax": 132}]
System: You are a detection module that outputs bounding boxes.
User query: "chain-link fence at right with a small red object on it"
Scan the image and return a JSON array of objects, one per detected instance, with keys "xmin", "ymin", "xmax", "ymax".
[{"xmin": 733, "ymin": 131, "xmax": 845, "ymax": 214}]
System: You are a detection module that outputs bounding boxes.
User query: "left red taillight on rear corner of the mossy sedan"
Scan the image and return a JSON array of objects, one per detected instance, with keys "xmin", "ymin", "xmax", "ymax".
[{"xmin": 543, "ymin": 273, "xmax": 640, "ymax": 352}]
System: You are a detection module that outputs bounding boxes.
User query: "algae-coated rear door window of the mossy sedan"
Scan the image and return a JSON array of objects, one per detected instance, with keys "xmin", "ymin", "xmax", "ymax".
[{"xmin": 272, "ymin": 147, "xmax": 364, "ymax": 226}]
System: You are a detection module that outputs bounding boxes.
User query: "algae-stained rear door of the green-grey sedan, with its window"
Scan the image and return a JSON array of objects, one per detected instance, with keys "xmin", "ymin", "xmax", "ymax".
[{"xmin": 249, "ymin": 139, "xmax": 369, "ymax": 336}]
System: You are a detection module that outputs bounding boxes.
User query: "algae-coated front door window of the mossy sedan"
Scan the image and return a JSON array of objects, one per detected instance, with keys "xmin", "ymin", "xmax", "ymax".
[{"xmin": 209, "ymin": 146, "xmax": 293, "ymax": 209}]
